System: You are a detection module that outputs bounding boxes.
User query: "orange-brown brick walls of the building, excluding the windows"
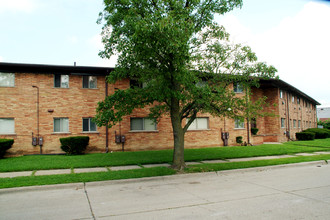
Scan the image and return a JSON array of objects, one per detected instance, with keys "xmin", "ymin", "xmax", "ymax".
[{"xmin": 0, "ymin": 63, "xmax": 318, "ymax": 155}]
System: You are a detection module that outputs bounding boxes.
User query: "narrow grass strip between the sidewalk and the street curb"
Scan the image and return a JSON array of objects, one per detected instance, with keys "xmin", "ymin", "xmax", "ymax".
[{"xmin": 0, "ymin": 155, "xmax": 330, "ymax": 188}]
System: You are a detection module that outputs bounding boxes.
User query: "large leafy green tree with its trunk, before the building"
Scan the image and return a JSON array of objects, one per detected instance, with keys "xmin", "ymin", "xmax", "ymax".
[{"xmin": 95, "ymin": 0, "xmax": 276, "ymax": 170}]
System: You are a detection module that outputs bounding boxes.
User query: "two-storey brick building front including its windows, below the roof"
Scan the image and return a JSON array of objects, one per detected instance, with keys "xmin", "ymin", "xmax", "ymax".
[{"xmin": 0, "ymin": 63, "xmax": 319, "ymax": 155}]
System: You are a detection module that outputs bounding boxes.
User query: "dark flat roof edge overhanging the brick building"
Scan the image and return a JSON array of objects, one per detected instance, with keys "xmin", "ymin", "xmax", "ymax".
[{"xmin": 0, "ymin": 62, "xmax": 321, "ymax": 105}]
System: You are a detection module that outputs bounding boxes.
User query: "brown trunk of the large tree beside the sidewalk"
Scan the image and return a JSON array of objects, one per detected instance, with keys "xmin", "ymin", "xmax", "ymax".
[{"xmin": 171, "ymin": 100, "xmax": 186, "ymax": 170}]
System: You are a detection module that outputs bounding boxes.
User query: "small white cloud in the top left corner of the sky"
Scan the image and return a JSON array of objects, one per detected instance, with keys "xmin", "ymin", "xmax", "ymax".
[{"xmin": 0, "ymin": 0, "xmax": 38, "ymax": 13}]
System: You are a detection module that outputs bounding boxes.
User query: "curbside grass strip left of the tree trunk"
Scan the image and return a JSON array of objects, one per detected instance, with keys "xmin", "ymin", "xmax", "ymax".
[{"xmin": 0, "ymin": 167, "xmax": 176, "ymax": 188}]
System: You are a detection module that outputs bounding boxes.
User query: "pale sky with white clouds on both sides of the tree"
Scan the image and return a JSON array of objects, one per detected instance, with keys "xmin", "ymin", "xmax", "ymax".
[{"xmin": 0, "ymin": 0, "xmax": 330, "ymax": 107}]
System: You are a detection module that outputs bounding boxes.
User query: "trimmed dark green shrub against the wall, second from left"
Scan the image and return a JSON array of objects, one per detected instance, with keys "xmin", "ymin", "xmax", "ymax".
[{"xmin": 60, "ymin": 136, "xmax": 89, "ymax": 155}]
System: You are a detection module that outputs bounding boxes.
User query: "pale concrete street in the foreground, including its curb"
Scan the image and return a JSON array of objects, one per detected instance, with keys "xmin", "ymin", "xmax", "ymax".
[{"xmin": 0, "ymin": 163, "xmax": 330, "ymax": 220}]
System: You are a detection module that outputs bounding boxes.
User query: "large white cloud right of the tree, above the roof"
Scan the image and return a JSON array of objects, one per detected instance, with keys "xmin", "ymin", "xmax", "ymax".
[{"xmin": 221, "ymin": 2, "xmax": 330, "ymax": 103}]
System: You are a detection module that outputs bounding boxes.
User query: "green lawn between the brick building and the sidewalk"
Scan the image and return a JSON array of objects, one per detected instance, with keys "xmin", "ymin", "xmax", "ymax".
[{"xmin": 0, "ymin": 138, "xmax": 330, "ymax": 172}]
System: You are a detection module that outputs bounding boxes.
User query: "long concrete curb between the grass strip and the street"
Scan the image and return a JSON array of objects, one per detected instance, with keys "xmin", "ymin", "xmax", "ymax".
[{"xmin": 0, "ymin": 160, "xmax": 330, "ymax": 195}]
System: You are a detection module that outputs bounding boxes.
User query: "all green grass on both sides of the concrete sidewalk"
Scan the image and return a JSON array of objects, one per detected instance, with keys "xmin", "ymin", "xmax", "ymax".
[{"xmin": 0, "ymin": 139, "xmax": 330, "ymax": 188}]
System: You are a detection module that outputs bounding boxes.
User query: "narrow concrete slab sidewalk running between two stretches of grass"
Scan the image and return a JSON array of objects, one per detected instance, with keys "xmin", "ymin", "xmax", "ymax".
[{"xmin": 0, "ymin": 151, "xmax": 330, "ymax": 178}]
